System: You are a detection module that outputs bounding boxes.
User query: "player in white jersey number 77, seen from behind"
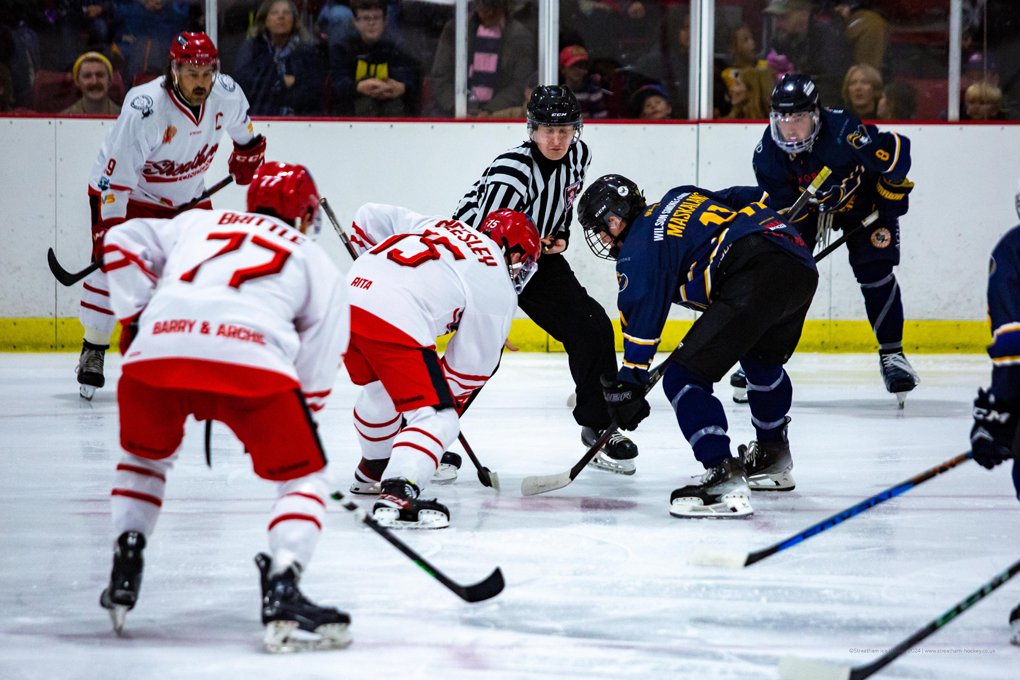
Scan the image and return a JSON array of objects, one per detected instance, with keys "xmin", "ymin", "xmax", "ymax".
[{"xmin": 100, "ymin": 163, "xmax": 350, "ymax": 651}]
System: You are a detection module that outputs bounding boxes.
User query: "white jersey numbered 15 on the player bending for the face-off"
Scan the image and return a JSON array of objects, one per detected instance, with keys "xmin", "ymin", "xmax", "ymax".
[{"xmin": 347, "ymin": 203, "xmax": 517, "ymax": 399}]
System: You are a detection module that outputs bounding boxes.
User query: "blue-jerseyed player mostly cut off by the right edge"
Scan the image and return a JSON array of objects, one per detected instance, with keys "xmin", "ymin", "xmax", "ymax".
[{"xmin": 970, "ymin": 186, "xmax": 1020, "ymax": 644}]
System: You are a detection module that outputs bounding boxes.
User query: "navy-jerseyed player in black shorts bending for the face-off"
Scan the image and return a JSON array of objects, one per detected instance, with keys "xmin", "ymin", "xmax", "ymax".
[{"xmin": 577, "ymin": 174, "xmax": 818, "ymax": 517}]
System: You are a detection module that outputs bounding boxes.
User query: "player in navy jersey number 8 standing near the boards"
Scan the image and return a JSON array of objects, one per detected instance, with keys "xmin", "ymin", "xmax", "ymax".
[{"xmin": 752, "ymin": 73, "xmax": 919, "ymax": 407}]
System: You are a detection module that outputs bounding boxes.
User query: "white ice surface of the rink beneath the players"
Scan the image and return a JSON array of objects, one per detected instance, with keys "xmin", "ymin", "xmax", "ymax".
[{"xmin": 0, "ymin": 354, "xmax": 1020, "ymax": 680}]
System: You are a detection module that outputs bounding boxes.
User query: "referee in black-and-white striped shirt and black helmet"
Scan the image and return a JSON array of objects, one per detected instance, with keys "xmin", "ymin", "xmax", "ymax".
[{"xmin": 454, "ymin": 86, "xmax": 638, "ymax": 475}]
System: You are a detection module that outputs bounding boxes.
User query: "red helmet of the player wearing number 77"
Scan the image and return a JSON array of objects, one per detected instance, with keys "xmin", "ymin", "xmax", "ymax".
[{"xmin": 248, "ymin": 161, "xmax": 321, "ymax": 237}]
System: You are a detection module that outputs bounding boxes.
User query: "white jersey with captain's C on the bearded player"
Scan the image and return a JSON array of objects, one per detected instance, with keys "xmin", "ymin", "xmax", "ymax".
[{"xmin": 89, "ymin": 73, "xmax": 254, "ymax": 220}]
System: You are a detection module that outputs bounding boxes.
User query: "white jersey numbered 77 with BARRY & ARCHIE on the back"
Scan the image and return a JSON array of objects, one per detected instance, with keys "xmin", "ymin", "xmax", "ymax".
[{"xmin": 103, "ymin": 210, "xmax": 349, "ymax": 410}]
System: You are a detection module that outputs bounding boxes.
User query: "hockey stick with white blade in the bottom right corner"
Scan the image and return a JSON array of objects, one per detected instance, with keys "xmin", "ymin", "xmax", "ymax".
[{"xmin": 779, "ymin": 560, "xmax": 1020, "ymax": 680}]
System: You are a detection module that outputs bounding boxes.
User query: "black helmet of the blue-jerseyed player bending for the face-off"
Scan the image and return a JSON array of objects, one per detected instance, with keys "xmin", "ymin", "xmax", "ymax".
[{"xmin": 577, "ymin": 174, "xmax": 646, "ymax": 260}]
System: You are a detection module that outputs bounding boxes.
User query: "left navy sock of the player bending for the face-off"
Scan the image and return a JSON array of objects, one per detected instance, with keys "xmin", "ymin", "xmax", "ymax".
[{"xmin": 662, "ymin": 363, "xmax": 729, "ymax": 469}]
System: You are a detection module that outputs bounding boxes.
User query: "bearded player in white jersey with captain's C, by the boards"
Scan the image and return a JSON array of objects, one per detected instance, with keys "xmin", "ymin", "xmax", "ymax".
[{"xmin": 77, "ymin": 33, "xmax": 265, "ymax": 399}]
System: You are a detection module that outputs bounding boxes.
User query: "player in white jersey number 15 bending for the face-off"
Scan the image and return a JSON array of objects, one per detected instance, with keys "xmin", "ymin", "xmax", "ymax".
[{"xmin": 344, "ymin": 203, "xmax": 542, "ymax": 528}]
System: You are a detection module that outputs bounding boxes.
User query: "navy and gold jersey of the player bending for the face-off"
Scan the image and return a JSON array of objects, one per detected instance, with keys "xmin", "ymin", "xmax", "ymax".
[{"xmin": 616, "ymin": 186, "xmax": 815, "ymax": 381}]
